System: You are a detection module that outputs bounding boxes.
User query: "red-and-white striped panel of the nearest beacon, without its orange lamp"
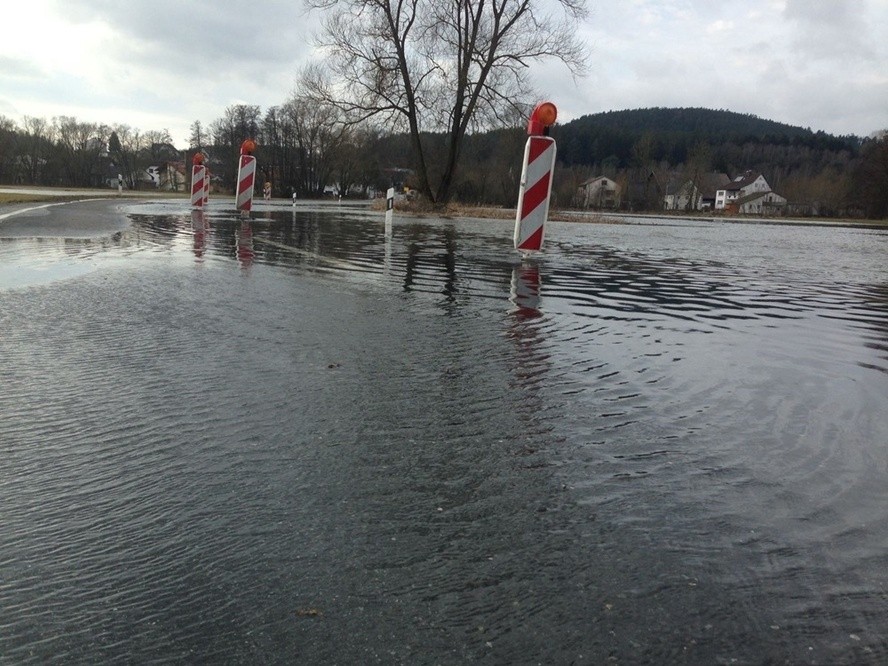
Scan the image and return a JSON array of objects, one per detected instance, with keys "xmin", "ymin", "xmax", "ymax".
[{"xmin": 515, "ymin": 136, "xmax": 555, "ymax": 251}]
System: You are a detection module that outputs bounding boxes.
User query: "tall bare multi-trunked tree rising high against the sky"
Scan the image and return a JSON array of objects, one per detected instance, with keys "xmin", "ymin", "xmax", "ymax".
[{"xmin": 305, "ymin": 0, "xmax": 586, "ymax": 203}]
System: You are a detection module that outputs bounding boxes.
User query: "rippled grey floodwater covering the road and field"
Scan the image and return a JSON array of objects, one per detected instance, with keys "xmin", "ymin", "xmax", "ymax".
[{"xmin": 0, "ymin": 202, "xmax": 888, "ymax": 664}]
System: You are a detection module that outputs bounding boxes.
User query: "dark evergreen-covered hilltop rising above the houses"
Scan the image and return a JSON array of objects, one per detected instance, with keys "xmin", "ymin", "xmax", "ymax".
[{"xmin": 553, "ymin": 107, "xmax": 860, "ymax": 168}]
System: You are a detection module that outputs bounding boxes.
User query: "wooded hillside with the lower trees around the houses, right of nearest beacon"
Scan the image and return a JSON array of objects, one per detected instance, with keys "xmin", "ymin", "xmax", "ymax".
[{"xmin": 553, "ymin": 108, "xmax": 888, "ymax": 217}]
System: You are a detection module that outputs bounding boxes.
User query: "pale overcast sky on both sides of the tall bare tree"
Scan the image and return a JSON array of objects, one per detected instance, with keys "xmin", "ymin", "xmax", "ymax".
[{"xmin": 0, "ymin": 0, "xmax": 888, "ymax": 148}]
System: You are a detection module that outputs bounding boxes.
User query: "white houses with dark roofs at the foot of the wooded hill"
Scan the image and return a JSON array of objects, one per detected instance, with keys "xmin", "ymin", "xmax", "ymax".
[{"xmin": 577, "ymin": 171, "xmax": 786, "ymax": 215}]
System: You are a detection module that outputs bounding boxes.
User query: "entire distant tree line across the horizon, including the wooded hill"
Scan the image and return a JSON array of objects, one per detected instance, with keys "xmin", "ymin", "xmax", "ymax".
[{"xmin": 0, "ymin": 104, "xmax": 888, "ymax": 218}]
